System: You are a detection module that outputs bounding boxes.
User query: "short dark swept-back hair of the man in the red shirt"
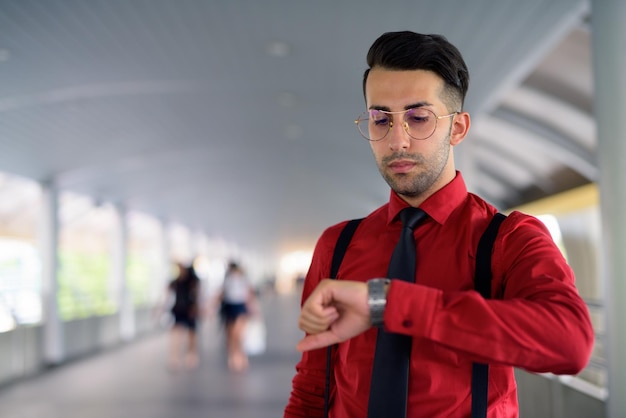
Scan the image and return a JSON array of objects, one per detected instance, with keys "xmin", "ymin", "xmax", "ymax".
[{"xmin": 363, "ymin": 31, "xmax": 469, "ymax": 111}]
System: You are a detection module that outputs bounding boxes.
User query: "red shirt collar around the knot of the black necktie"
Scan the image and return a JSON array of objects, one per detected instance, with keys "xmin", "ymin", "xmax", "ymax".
[{"xmin": 387, "ymin": 171, "xmax": 467, "ymax": 224}]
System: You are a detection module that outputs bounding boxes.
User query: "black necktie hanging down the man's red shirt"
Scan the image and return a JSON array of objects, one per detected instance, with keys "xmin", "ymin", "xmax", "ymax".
[{"xmin": 367, "ymin": 207, "xmax": 426, "ymax": 418}]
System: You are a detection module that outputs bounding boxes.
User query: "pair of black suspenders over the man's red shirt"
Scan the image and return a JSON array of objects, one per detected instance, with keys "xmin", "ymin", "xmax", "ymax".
[{"xmin": 324, "ymin": 213, "xmax": 506, "ymax": 418}]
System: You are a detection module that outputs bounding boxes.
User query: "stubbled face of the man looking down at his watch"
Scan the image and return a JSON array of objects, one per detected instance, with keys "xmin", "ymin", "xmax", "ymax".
[{"xmin": 365, "ymin": 68, "xmax": 458, "ymax": 204}]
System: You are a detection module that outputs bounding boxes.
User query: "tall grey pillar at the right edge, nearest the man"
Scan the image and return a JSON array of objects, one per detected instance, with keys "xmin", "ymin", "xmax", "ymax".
[{"xmin": 591, "ymin": 0, "xmax": 626, "ymax": 418}]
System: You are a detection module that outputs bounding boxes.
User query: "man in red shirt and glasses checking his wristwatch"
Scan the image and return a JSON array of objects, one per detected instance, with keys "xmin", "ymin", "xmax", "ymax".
[{"xmin": 285, "ymin": 32, "xmax": 594, "ymax": 418}]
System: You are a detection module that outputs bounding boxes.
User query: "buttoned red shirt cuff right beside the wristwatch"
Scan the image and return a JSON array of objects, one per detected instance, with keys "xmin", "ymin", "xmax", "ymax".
[{"xmin": 384, "ymin": 280, "xmax": 443, "ymax": 337}]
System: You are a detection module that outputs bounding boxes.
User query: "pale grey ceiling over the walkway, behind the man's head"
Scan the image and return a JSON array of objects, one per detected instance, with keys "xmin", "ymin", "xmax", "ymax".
[{"xmin": 0, "ymin": 0, "xmax": 597, "ymax": 257}]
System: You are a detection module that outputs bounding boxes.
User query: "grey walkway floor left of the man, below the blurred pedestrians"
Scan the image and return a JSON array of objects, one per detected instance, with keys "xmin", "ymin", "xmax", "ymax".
[{"xmin": 0, "ymin": 295, "xmax": 302, "ymax": 418}]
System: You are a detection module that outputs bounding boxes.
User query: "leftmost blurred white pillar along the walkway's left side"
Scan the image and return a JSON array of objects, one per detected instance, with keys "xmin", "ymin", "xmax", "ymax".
[{"xmin": 39, "ymin": 183, "xmax": 65, "ymax": 365}]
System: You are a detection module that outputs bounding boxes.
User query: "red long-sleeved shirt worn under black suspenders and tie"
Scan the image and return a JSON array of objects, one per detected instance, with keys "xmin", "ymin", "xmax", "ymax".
[{"xmin": 284, "ymin": 173, "xmax": 594, "ymax": 418}]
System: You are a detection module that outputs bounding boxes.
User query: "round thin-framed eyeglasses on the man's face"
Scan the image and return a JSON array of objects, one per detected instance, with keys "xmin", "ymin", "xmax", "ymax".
[{"xmin": 354, "ymin": 107, "xmax": 461, "ymax": 141}]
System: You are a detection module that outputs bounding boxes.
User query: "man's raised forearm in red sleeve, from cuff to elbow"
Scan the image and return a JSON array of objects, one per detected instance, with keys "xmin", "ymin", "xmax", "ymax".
[{"xmin": 385, "ymin": 281, "xmax": 594, "ymax": 374}]
